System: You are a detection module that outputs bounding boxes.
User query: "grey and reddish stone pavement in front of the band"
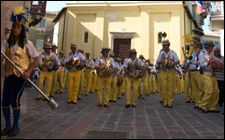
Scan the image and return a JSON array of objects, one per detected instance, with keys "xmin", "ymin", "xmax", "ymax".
[{"xmin": 1, "ymin": 84, "xmax": 224, "ymax": 139}]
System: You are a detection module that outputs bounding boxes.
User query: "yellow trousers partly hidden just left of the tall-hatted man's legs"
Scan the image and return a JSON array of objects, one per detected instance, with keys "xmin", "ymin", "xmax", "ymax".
[{"xmin": 184, "ymin": 72, "xmax": 195, "ymax": 101}]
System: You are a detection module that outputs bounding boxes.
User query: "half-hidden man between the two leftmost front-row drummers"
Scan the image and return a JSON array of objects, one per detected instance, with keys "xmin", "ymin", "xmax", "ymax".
[{"xmin": 57, "ymin": 51, "xmax": 66, "ymax": 93}]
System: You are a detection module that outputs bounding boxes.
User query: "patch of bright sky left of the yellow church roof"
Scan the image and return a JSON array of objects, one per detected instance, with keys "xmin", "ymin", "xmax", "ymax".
[{"xmin": 46, "ymin": 1, "xmax": 69, "ymax": 11}]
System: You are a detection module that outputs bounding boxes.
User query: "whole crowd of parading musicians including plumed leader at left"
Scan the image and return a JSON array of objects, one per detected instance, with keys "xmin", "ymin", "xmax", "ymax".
[{"xmin": 1, "ymin": 7, "xmax": 224, "ymax": 136}]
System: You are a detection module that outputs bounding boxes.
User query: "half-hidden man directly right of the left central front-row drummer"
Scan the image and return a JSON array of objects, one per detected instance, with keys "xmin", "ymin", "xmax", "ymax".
[{"xmin": 109, "ymin": 53, "xmax": 118, "ymax": 102}]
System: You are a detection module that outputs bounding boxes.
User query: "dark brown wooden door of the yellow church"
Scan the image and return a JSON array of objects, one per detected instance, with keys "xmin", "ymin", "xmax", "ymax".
[{"xmin": 113, "ymin": 38, "xmax": 131, "ymax": 62}]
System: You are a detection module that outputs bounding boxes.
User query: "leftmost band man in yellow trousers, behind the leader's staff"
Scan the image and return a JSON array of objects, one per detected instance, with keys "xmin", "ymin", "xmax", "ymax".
[{"xmin": 36, "ymin": 43, "xmax": 60, "ymax": 101}]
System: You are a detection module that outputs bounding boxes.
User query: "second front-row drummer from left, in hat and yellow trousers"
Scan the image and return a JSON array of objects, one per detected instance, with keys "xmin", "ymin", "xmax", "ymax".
[{"xmin": 66, "ymin": 43, "xmax": 86, "ymax": 104}]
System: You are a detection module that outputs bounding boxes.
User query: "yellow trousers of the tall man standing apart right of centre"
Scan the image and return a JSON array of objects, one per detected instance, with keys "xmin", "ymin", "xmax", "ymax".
[{"xmin": 161, "ymin": 69, "xmax": 176, "ymax": 106}]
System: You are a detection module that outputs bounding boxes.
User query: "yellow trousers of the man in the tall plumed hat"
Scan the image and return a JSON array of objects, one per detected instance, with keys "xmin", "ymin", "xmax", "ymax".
[{"xmin": 190, "ymin": 71, "xmax": 203, "ymax": 106}]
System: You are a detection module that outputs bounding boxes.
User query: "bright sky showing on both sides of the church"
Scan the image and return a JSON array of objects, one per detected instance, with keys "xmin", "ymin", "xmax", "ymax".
[{"xmin": 46, "ymin": 1, "xmax": 209, "ymax": 31}]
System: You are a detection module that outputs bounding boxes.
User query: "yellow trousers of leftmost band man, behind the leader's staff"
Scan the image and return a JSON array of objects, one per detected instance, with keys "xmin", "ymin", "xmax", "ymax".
[{"xmin": 37, "ymin": 71, "xmax": 52, "ymax": 98}]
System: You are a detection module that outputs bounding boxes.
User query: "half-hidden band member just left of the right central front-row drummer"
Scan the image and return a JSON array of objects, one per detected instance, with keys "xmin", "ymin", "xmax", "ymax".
[{"xmin": 116, "ymin": 58, "xmax": 124, "ymax": 99}]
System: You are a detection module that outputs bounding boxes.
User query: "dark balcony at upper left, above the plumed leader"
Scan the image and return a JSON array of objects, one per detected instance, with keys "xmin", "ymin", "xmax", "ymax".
[{"xmin": 29, "ymin": 1, "xmax": 47, "ymax": 27}]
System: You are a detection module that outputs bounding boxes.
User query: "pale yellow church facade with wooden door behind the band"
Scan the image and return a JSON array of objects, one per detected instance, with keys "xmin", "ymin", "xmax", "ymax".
[{"xmin": 53, "ymin": 1, "xmax": 200, "ymax": 63}]
